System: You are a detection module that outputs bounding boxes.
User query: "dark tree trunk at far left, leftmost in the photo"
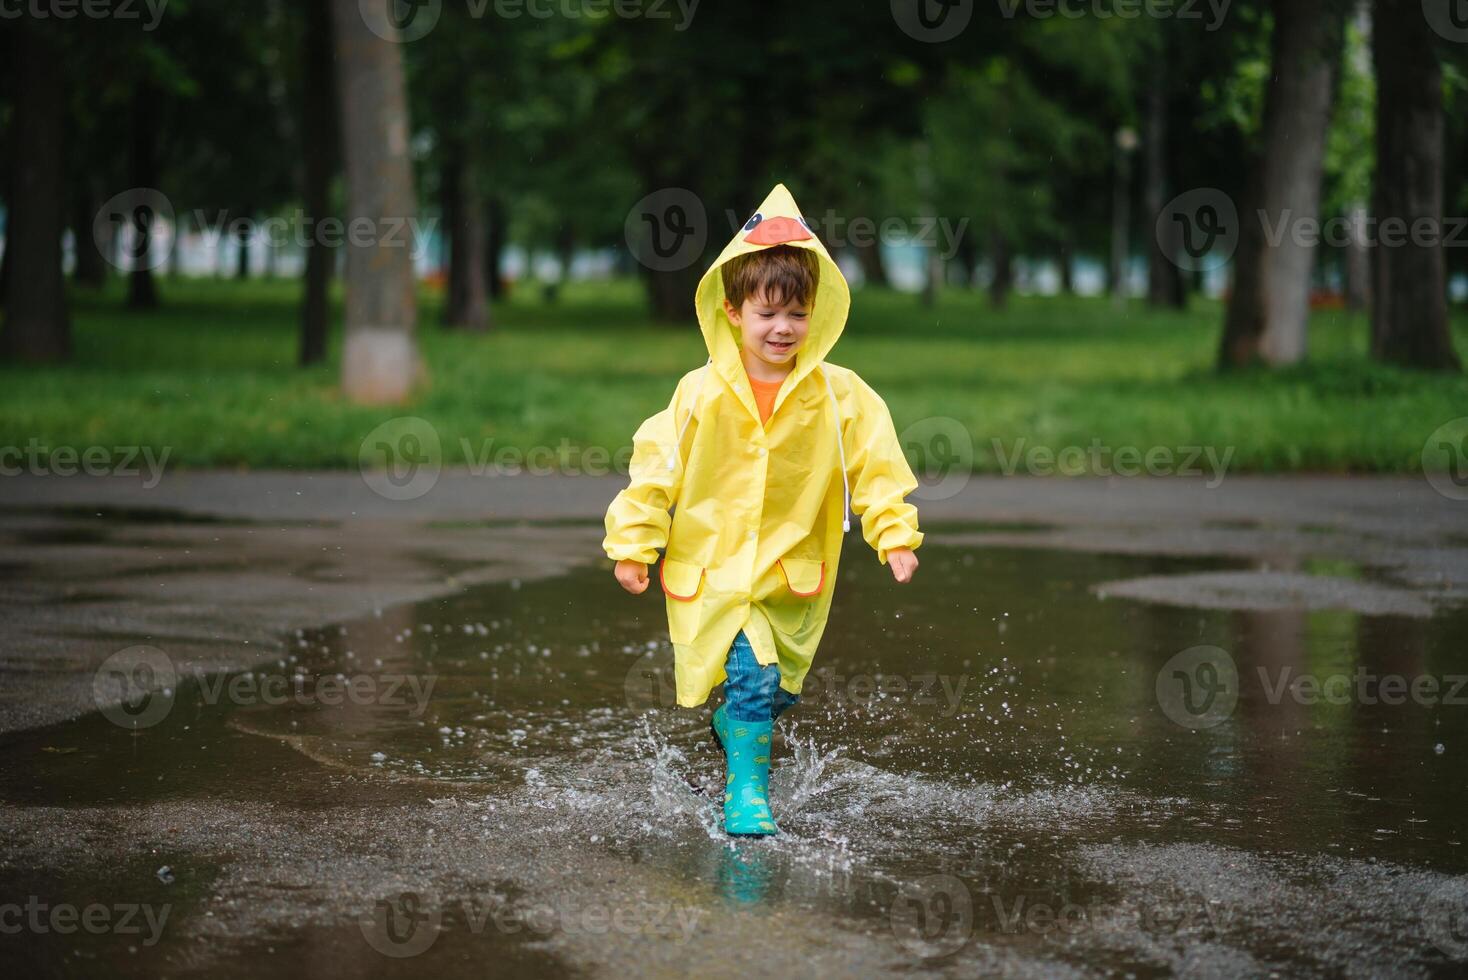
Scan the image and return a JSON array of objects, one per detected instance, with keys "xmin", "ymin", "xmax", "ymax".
[{"xmin": 0, "ymin": 18, "xmax": 70, "ymax": 361}]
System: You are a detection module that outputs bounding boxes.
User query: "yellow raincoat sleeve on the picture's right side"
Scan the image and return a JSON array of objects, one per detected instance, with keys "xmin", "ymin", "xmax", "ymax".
[{"xmin": 846, "ymin": 380, "xmax": 923, "ymax": 565}]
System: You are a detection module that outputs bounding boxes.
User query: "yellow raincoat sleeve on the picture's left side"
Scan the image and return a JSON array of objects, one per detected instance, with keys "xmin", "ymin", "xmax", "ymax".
[{"xmin": 602, "ymin": 379, "xmax": 687, "ymax": 565}]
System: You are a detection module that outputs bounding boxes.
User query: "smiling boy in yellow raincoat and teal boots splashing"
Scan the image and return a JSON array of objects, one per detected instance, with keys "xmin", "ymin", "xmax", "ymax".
[{"xmin": 602, "ymin": 185, "xmax": 923, "ymax": 836}]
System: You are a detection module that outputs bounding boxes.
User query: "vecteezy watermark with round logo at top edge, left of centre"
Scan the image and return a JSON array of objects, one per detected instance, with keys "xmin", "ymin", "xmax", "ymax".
[{"xmin": 357, "ymin": 0, "xmax": 702, "ymax": 44}]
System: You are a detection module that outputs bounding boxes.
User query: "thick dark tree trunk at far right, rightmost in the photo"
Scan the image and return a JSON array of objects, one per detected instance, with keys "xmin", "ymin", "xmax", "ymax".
[{"xmin": 1371, "ymin": 0, "xmax": 1461, "ymax": 371}]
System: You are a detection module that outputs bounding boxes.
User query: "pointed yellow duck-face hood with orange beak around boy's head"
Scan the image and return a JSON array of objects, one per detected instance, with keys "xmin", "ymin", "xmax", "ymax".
[{"xmin": 694, "ymin": 183, "xmax": 851, "ymax": 399}]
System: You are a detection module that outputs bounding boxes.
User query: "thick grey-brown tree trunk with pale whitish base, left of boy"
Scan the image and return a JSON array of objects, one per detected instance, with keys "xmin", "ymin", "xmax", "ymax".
[{"xmin": 332, "ymin": 0, "xmax": 421, "ymax": 403}]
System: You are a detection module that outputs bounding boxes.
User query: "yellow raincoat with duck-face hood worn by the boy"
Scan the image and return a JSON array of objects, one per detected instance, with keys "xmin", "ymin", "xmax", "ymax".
[{"xmin": 602, "ymin": 185, "xmax": 923, "ymax": 707}]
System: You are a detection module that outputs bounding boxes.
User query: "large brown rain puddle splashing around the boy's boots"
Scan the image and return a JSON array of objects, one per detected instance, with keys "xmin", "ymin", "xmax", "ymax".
[{"xmin": 0, "ymin": 531, "xmax": 1468, "ymax": 977}]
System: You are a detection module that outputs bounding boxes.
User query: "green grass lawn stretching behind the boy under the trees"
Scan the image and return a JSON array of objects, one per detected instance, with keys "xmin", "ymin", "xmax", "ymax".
[{"xmin": 0, "ymin": 280, "xmax": 1468, "ymax": 472}]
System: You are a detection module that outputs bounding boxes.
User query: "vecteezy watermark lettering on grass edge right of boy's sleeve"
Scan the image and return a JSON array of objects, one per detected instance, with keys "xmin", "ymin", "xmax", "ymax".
[{"xmin": 994, "ymin": 436, "xmax": 1233, "ymax": 490}]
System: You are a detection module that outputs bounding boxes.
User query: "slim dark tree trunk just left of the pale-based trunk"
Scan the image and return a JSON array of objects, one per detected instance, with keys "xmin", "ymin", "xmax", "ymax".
[{"xmin": 299, "ymin": 0, "xmax": 341, "ymax": 367}]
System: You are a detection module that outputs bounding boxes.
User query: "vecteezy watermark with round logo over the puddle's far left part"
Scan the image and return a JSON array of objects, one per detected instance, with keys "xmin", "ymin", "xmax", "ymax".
[{"xmin": 92, "ymin": 646, "xmax": 437, "ymax": 731}]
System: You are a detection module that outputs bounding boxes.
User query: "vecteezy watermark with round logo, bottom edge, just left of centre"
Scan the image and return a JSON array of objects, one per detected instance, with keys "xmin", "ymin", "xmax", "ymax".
[{"xmin": 358, "ymin": 892, "xmax": 705, "ymax": 959}]
